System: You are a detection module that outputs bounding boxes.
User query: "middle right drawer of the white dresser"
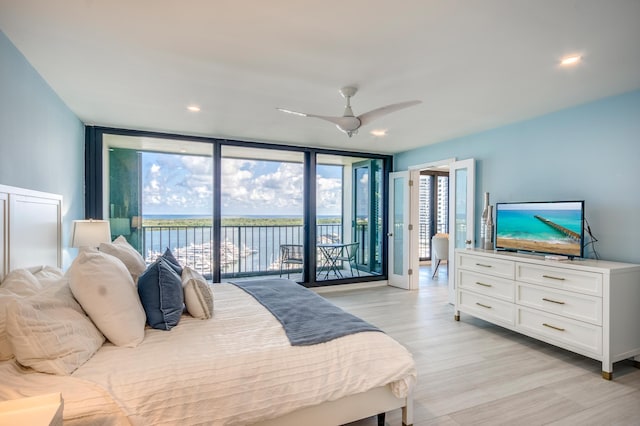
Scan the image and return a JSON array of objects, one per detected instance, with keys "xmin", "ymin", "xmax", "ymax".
[{"xmin": 516, "ymin": 283, "xmax": 602, "ymax": 325}]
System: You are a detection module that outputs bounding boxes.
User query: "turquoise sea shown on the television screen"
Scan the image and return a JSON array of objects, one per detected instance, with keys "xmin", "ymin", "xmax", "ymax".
[{"xmin": 496, "ymin": 210, "xmax": 582, "ymax": 242}]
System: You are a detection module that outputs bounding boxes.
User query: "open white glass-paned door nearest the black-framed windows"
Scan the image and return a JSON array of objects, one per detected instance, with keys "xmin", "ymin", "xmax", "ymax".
[{"xmin": 388, "ymin": 171, "xmax": 418, "ymax": 290}]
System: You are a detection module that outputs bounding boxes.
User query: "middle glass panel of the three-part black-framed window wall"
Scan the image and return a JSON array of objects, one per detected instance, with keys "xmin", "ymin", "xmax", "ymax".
[{"xmin": 220, "ymin": 146, "xmax": 305, "ymax": 281}]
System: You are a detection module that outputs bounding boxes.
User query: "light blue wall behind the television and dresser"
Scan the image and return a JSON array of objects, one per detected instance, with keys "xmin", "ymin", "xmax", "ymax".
[{"xmin": 394, "ymin": 91, "xmax": 640, "ymax": 263}]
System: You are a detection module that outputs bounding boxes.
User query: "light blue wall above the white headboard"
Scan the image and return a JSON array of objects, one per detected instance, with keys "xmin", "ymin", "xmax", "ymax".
[{"xmin": 0, "ymin": 31, "xmax": 84, "ymax": 266}]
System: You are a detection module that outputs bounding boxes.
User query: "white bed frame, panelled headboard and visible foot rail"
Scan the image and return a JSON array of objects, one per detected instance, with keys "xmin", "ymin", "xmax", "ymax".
[{"xmin": 0, "ymin": 185, "xmax": 413, "ymax": 426}]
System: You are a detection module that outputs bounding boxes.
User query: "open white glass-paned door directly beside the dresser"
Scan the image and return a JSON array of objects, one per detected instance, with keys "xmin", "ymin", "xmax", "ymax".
[{"xmin": 447, "ymin": 158, "xmax": 476, "ymax": 303}]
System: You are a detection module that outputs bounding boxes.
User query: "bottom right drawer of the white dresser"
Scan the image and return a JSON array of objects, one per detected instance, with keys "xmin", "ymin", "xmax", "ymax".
[{"xmin": 516, "ymin": 307, "xmax": 602, "ymax": 358}]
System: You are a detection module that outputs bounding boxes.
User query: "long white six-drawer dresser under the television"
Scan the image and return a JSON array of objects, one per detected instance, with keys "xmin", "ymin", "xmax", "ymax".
[{"xmin": 455, "ymin": 249, "xmax": 640, "ymax": 380}]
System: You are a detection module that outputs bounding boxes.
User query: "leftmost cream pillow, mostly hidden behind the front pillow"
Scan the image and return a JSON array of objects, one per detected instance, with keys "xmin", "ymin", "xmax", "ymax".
[{"xmin": 0, "ymin": 269, "xmax": 42, "ymax": 361}]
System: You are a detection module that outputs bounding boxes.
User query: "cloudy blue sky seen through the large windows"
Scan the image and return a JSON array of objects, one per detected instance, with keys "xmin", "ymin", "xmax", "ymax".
[{"xmin": 142, "ymin": 152, "xmax": 342, "ymax": 216}]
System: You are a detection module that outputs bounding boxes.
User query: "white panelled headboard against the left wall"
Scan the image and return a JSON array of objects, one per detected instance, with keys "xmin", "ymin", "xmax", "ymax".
[{"xmin": 0, "ymin": 185, "xmax": 62, "ymax": 281}]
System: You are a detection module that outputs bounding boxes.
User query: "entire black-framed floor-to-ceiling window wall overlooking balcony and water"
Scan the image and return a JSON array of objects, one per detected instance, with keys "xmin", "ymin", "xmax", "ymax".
[{"xmin": 90, "ymin": 127, "xmax": 391, "ymax": 286}]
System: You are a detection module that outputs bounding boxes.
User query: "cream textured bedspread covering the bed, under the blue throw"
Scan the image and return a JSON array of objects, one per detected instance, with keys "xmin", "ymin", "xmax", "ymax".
[{"xmin": 0, "ymin": 284, "xmax": 416, "ymax": 425}]
